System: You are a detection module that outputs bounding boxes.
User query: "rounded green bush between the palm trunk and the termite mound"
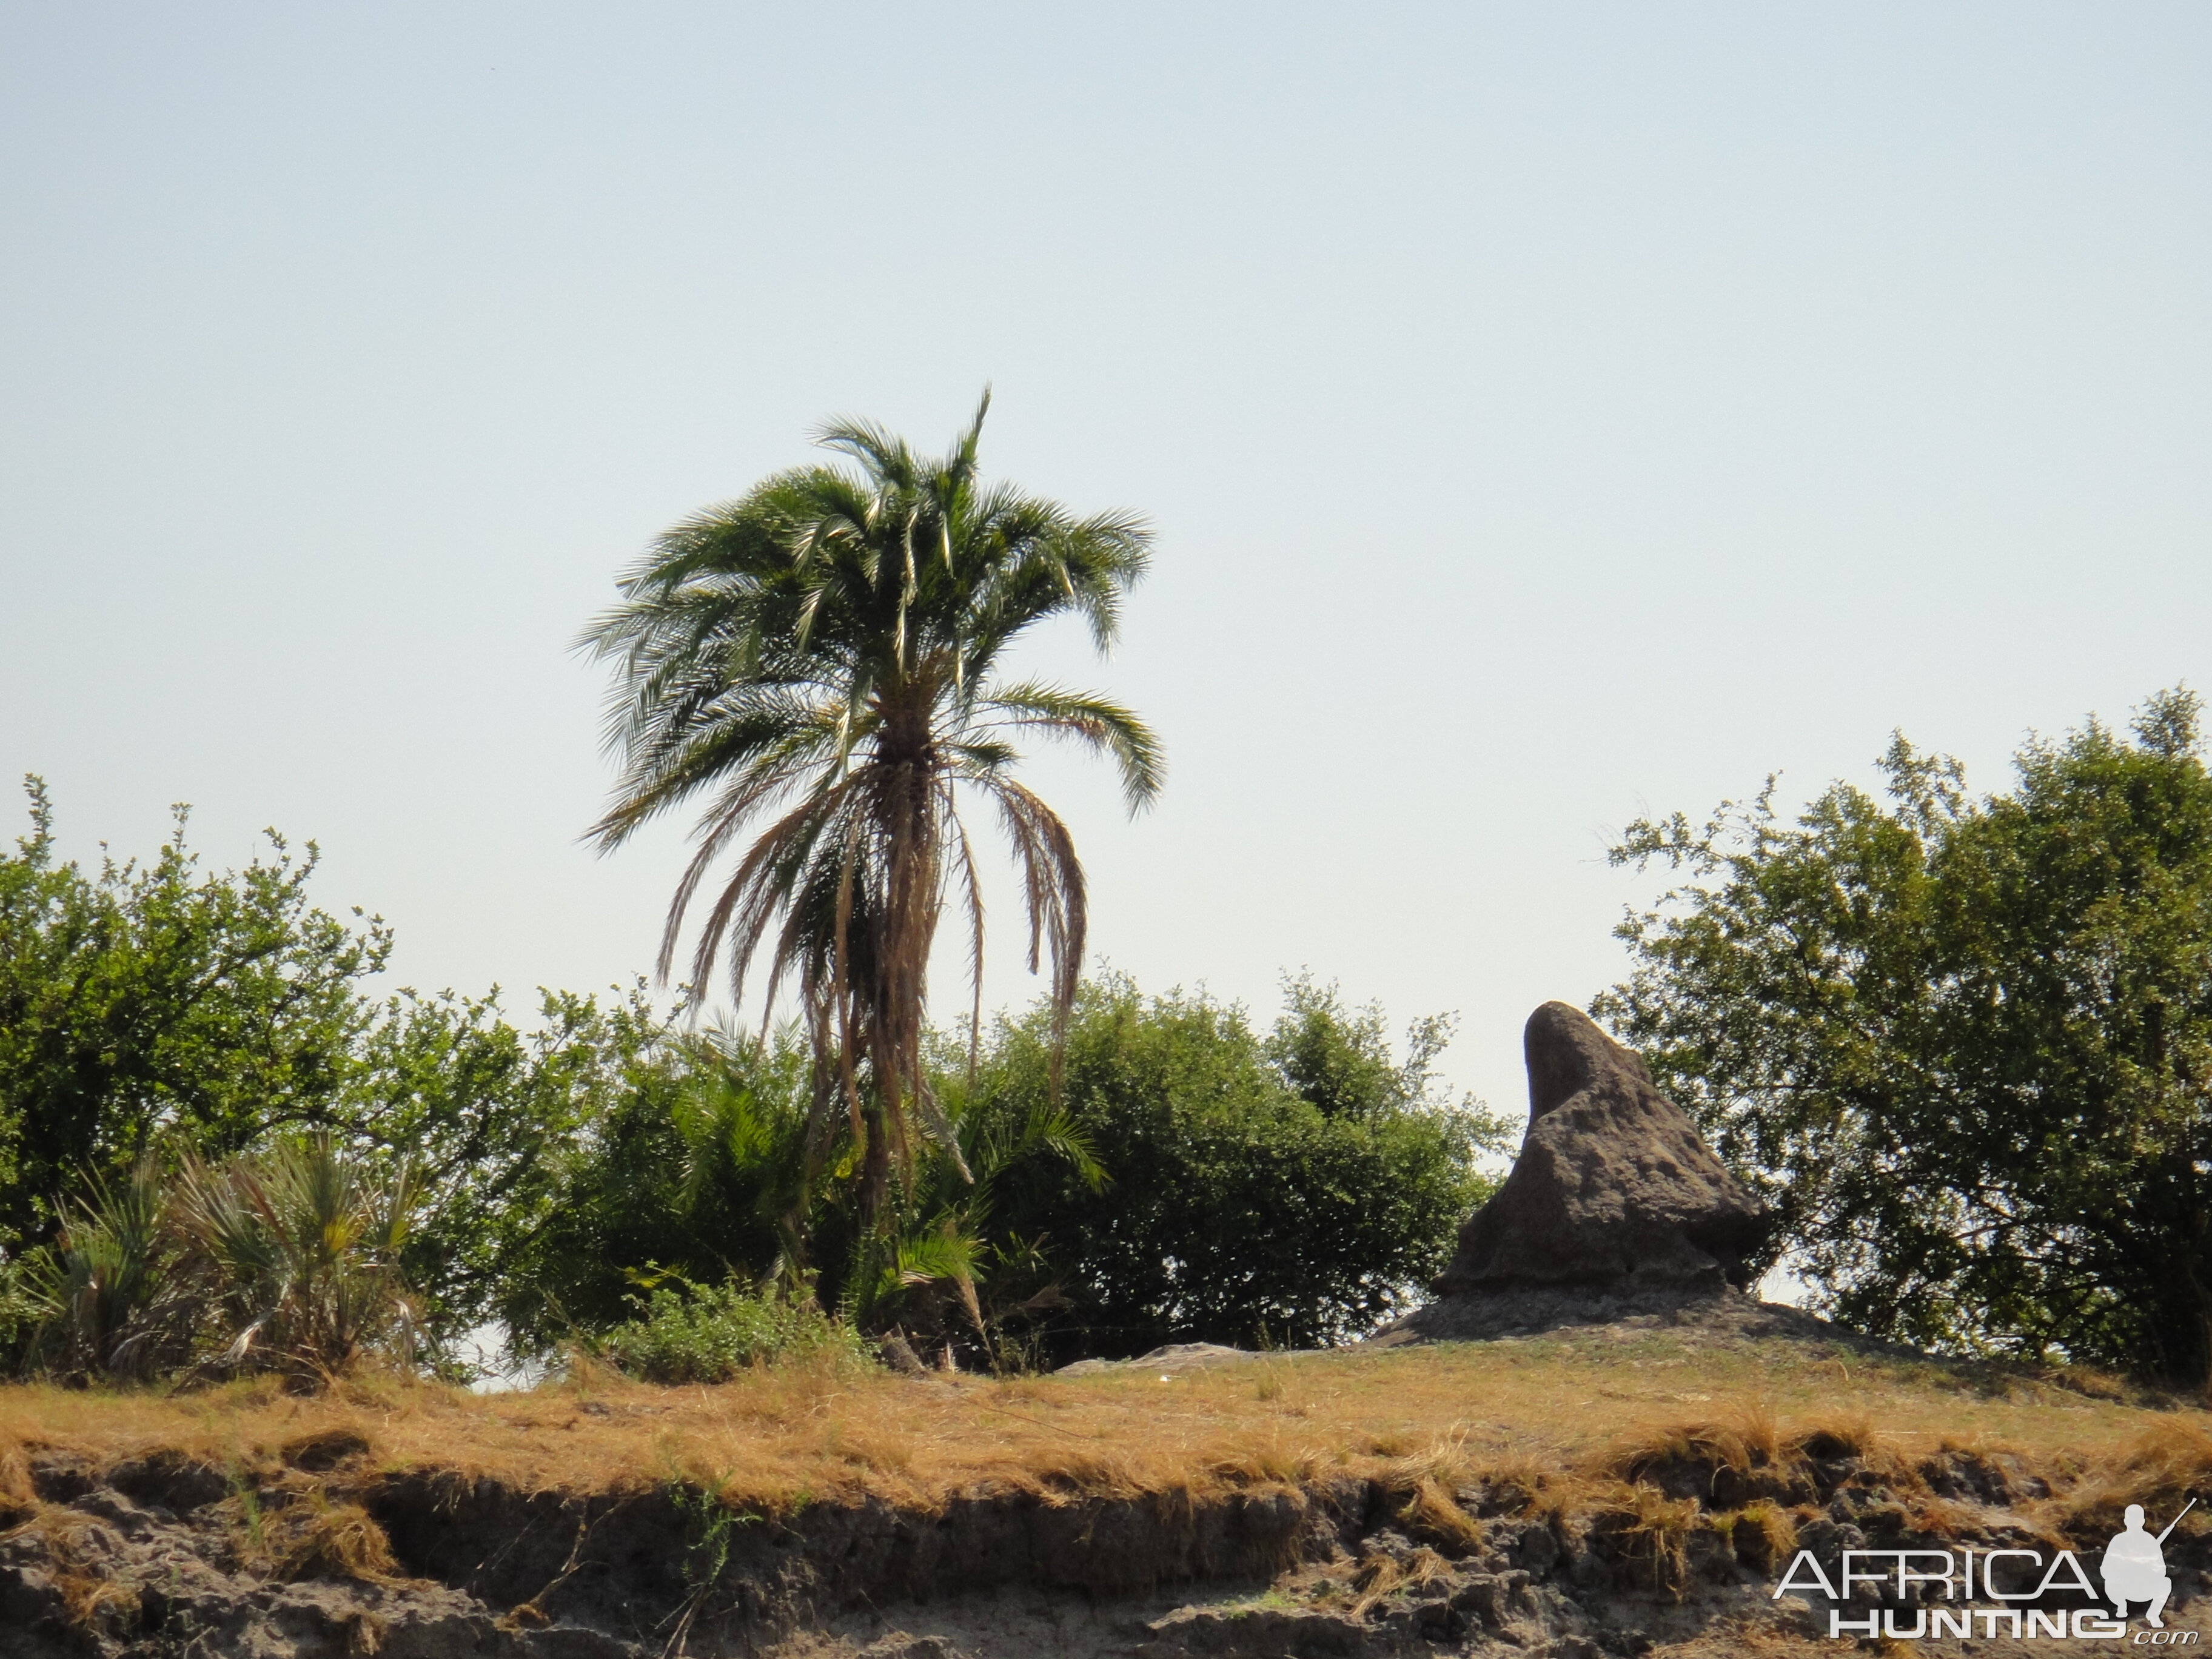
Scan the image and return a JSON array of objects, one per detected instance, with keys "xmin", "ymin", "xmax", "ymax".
[{"xmin": 969, "ymin": 976, "xmax": 1509, "ymax": 1362}]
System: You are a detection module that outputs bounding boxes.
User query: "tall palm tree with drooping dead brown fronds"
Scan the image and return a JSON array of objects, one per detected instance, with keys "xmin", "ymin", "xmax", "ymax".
[{"xmin": 580, "ymin": 392, "xmax": 1161, "ymax": 1219}]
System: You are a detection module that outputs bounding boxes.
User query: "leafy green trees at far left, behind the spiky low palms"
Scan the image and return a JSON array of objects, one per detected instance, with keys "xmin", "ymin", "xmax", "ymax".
[{"xmin": 0, "ymin": 779, "xmax": 677, "ymax": 1356}]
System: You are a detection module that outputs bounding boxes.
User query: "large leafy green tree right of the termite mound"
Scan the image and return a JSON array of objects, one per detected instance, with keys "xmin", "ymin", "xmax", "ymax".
[{"xmin": 1593, "ymin": 690, "xmax": 2212, "ymax": 1385}]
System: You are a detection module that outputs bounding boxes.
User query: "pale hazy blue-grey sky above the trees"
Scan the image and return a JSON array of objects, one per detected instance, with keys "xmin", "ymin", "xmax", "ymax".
[{"xmin": 0, "ymin": 0, "xmax": 2212, "ymax": 1110}]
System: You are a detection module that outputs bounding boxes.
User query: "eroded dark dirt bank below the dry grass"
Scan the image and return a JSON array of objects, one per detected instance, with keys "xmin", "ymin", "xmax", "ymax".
[{"xmin": 0, "ymin": 1423, "xmax": 2212, "ymax": 1659}]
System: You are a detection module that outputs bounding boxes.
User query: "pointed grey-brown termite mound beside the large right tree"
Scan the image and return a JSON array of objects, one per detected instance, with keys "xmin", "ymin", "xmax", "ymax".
[{"xmin": 1393, "ymin": 1002, "xmax": 1772, "ymax": 1336}]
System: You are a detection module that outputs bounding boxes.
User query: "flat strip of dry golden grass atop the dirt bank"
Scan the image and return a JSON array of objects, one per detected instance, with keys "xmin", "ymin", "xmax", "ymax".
[{"xmin": 0, "ymin": 1329, "xmax": 2212, "ymax": 1530}]
